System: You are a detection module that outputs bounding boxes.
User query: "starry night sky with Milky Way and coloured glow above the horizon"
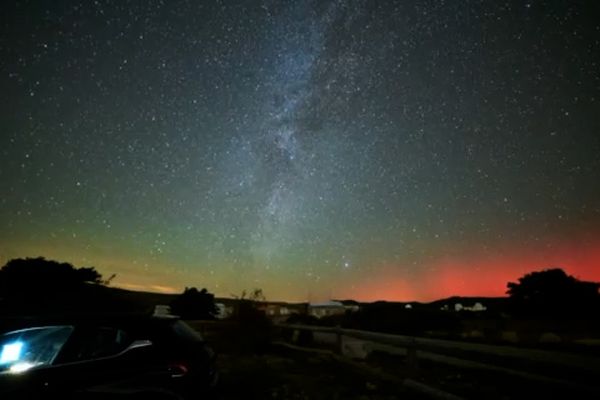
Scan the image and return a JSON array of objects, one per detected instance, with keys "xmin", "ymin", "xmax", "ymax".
[{"xmin": 0, "ymin": 0, "xmax": 600, "ymax": 301}]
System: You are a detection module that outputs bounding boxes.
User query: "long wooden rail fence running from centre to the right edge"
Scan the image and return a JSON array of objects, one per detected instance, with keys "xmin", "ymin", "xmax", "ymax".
[{"xmin": 277, "ymin": 324, "xmax": 600, "ymax": 398}]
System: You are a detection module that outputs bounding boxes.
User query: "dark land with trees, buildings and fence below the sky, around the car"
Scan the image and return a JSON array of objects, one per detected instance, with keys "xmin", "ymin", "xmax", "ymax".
[{"xmin": 0, "ymin": 257, "xmax": 600, "ymax": 399}]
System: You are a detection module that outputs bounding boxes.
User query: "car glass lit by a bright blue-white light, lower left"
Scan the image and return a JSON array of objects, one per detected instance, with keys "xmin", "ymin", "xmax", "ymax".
[{"xmin": 0, "ymin": 326, "xmax": 73, "ymax": 373}]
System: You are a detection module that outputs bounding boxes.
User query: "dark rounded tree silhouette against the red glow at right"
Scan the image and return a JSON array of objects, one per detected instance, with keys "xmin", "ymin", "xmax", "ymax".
[{"xmin": 507, "ymin": 268, "xmax": 600, "ymax": 316}]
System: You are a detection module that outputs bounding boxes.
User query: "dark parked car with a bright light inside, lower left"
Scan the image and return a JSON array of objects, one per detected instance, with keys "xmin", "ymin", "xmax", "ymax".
[{"xmin": 0, "ymin": 315, "xmax": 217, "ymax": 399}]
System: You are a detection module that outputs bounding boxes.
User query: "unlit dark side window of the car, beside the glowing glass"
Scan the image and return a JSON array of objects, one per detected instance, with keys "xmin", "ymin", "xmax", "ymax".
[{"xmin": 61, "ymin": 326, "xmax": 131, "ymax": 363}]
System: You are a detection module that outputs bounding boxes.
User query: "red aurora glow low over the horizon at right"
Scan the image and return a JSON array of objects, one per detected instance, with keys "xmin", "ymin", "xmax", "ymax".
[{"xmin": 342, "ymin": 236, "xmax": 600, "ymax": 301}]
